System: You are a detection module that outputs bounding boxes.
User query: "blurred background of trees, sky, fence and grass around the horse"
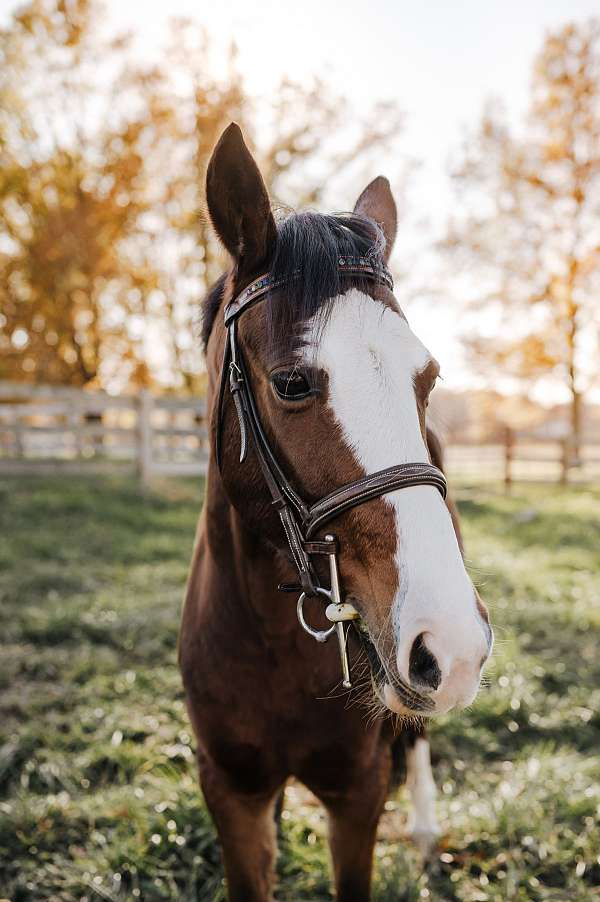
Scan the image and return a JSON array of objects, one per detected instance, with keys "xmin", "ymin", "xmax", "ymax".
[{"xmin": 0, "ymin": 0, "xmax": 600, "ymax": 900}]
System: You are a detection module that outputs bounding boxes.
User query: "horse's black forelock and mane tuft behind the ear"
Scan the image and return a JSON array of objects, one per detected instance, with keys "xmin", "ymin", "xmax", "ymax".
[{"xmin": 202, "ymin": 212, "xmax": 385, "ymax": 350}]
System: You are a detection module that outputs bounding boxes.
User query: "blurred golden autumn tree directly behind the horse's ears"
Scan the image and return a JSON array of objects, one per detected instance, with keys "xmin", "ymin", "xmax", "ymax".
[{"xmin": 150, "ymin": 20, "xmax": 405, "ymax": 390}]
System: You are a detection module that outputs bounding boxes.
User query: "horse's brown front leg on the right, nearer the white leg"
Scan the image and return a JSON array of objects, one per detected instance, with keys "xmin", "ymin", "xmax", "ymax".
[{"xmin": 312, "ymin": 765, "xmax": 389, "ymax": 902}]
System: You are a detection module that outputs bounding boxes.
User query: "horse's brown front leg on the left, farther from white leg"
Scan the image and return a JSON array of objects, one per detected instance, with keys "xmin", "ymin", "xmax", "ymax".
[{"xmin": 200, "ymin": 765, "xmax": 279, "ymax": 902}]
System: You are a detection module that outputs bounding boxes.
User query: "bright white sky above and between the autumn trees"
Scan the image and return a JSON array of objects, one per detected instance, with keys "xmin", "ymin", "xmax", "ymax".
[{"xmin": 0, "ymin": 0, "xmax": 600, "ymax": 400}]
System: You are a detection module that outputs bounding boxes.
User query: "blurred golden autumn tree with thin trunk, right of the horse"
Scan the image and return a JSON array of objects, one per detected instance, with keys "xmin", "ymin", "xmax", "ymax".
[{"xmin": 446, "ymin": 21, "xmax": 600, "ymax": 457}]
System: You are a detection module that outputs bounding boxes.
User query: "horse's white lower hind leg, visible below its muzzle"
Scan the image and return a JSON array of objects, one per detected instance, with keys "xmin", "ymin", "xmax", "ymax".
[{"xmin": 406, "ymin": 735, "xmax": 440, "ymax": 858}]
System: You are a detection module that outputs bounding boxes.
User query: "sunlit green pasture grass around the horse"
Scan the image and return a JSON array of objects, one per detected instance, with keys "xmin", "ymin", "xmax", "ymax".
[{"xmin": 0, "ymin": 478, "xmax": 600, "ymax": 902}]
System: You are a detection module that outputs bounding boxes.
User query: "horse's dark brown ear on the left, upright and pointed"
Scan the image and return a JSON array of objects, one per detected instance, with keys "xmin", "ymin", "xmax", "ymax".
[{"xmin": 206, "ymin": 122, "xmax": 277, "ymax": 272}]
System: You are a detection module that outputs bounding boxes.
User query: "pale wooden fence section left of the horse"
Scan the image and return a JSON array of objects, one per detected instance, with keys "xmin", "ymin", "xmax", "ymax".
[{"xmin": 0, "ymin": 382, "xmax": 208, "ymax": 482}]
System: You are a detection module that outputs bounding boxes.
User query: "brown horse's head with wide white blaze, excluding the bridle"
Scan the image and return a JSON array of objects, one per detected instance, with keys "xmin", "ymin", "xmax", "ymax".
[{"xmin": 207, "ymin": 125, "xmax": 492, "ymax": 713}]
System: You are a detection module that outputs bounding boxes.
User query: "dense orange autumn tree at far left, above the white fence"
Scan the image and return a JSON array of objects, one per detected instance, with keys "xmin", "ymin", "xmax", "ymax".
[{"xmin": 0, "ymin": 0, "xmax": 172, "ymax": 385}]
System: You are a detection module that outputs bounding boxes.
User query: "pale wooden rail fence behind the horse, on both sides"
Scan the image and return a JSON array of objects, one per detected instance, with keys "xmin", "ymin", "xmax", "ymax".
[{"xmin": 0, "ymin": 382, "xmax": 600, "ymax": 489}]
